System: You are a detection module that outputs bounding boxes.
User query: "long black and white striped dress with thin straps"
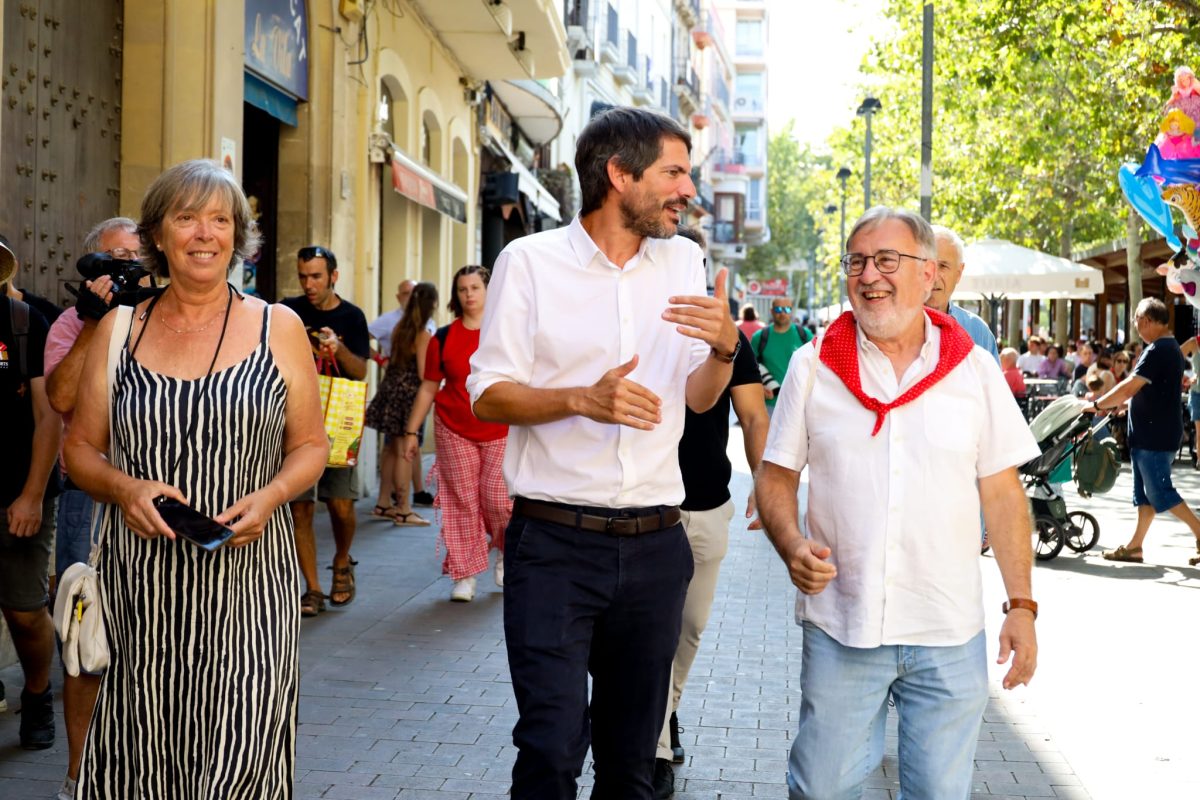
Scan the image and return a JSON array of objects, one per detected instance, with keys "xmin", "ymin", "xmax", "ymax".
[{"xmin": 76, "ymin": 307, "xmax": 300, "ymax": 800}]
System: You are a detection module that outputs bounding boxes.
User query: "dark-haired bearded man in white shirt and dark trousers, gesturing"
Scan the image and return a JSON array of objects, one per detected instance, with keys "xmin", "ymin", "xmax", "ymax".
[{"xmin": 467, "ymin": 108, "xmax": 739, "ymax": 800}]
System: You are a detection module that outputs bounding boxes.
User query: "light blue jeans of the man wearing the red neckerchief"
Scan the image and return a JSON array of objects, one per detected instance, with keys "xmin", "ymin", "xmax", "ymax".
[{"xmin": 787, "ymin": 622, "xmax": 988, "ymax": 800}]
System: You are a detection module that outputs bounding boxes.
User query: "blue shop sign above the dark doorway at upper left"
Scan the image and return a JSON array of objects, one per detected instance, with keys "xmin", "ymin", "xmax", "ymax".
[{"xmin": 246, "ymin": 0, "xmax": 308, "ymax": 100}]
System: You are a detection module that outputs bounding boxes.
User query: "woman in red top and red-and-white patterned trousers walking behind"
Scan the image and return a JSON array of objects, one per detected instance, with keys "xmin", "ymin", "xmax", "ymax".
[{"xmin": 403, "ymin": 265, "xmax": 512, "ymax": 602}]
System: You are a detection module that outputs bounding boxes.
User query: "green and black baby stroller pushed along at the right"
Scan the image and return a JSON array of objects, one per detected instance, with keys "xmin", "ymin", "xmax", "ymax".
[{"xmin": 1016, "ymin": 396, "xmax": 1121, "ymax": 561}]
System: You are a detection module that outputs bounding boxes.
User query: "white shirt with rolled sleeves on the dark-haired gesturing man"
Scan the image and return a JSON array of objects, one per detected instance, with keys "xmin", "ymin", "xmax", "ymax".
[{"xmin": 467, "ymin": 218, "xmax": 709, "ymax": 509}]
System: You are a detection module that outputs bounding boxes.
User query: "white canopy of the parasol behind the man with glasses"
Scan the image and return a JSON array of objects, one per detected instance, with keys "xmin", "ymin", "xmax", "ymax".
[{"xmin": 954, "ymin": 239, "xmax": 1104, "ymax": 300}]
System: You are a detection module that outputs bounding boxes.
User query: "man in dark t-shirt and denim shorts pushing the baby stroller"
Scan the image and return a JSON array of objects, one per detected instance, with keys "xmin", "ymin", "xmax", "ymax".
[{"xmin": 1096, "ymin": 297, "xmax": 1200, "ymax": 566}]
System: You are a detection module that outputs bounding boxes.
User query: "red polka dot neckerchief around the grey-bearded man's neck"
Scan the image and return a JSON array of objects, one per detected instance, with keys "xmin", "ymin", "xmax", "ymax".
[{"xmin": 821, "ymin": 308, "xmax": 974, "ymax": 437}]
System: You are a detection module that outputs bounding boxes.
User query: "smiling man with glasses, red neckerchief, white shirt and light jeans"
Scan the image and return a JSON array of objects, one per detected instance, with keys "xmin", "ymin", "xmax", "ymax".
[{"xmin": 756, "ymin": 206, "xmax": 1039, "ymax": 800}]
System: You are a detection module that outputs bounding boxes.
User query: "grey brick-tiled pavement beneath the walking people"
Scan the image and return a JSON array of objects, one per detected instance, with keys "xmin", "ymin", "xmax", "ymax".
[{"xmin": 0, "ymin": 453, "xmax": 1090, "ymax": 800}]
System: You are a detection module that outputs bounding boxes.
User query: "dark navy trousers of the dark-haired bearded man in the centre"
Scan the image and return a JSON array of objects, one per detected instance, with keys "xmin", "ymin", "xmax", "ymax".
[{"xmin": 504, "ymin": 510, "xmax": 692, "ymax": 800}]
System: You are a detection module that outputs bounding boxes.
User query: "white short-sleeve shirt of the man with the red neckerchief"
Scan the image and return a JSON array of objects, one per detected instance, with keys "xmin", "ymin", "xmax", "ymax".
[{"xmin": 763, "ymin": 317, "xmax": 1040, "ymax": 648}]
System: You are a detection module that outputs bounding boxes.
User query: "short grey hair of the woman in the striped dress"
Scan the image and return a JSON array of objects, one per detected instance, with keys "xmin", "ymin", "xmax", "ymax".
[{"xmin": 138, "ymin": 158, "xmax": 263, "ymax": 277}]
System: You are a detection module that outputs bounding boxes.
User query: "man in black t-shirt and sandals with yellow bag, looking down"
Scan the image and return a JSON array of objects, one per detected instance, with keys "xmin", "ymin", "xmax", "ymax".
[{"xmin": 283, "ymin": 247, "xmax": 371, "ymax": 616}]
